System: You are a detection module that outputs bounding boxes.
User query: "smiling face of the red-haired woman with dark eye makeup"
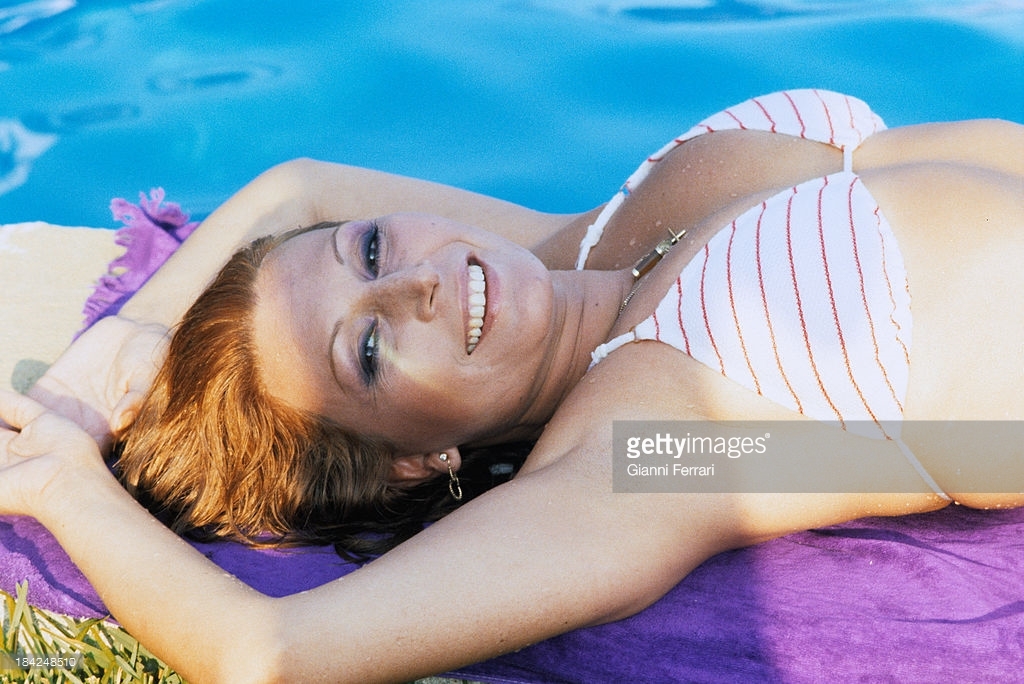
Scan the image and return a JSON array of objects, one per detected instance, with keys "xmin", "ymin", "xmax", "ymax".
[{"xmin": 254, "ymin": 214, "xmax": 555, "ymax": 455}]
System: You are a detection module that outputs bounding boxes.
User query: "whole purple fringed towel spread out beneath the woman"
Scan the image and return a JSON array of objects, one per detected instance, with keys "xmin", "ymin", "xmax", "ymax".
[{"xmin": 0, "ymin": 190, "xmax": 1024, "ymax": 683}]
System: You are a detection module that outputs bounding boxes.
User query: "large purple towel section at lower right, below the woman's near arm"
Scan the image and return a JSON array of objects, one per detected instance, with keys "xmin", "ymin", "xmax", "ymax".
[{"xmin": 463, "ymin": 506, "xmax": 1024, "ymax": 683}]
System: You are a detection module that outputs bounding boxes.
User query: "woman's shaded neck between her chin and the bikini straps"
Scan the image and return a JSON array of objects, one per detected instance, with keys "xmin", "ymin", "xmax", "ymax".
[{"xmin": 477, "ymin": 269, "xmax": 633, "ymax": 443}]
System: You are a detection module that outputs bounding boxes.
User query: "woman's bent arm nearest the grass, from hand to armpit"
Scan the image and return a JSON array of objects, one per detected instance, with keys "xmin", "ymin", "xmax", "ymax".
[{"xmin": 0, "ymin": 387, "xmax": 728, "ymax": 682}]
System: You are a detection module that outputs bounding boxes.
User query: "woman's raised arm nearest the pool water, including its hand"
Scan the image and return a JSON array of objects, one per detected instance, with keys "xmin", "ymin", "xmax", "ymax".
[{"xmin": 30, "ymin": 159, "xmax": 573, "ymax": 444}]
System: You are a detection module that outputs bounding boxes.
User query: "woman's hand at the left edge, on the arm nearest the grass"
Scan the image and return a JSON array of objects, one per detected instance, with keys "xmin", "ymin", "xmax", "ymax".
[{"xmin": 0, "ymin": 390, "xmax": 111, "ymax": 518}]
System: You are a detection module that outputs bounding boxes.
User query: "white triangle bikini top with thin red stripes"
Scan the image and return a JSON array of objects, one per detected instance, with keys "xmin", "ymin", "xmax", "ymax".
[{"xmin": 577, "ymin": 90, "xmax": 911, "ymax": 440}]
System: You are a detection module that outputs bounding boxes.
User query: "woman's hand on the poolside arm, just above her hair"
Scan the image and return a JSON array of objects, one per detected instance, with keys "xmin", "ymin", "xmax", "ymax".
[{"xmin": 28, "ymin": 316, "xmax": 167, "ymax": 451}]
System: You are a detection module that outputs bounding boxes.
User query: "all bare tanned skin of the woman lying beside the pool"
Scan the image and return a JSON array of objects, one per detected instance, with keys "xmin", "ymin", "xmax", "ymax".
[{"xmin": 0, "ymin": 121, "xmax": 1024, "ymax": 684}]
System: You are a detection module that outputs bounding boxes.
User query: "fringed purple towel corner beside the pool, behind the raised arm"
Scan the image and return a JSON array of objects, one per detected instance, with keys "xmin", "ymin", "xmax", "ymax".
[{"xmin": 76, "ymin": 187, "xmax": 199, "ymax": 337}]
